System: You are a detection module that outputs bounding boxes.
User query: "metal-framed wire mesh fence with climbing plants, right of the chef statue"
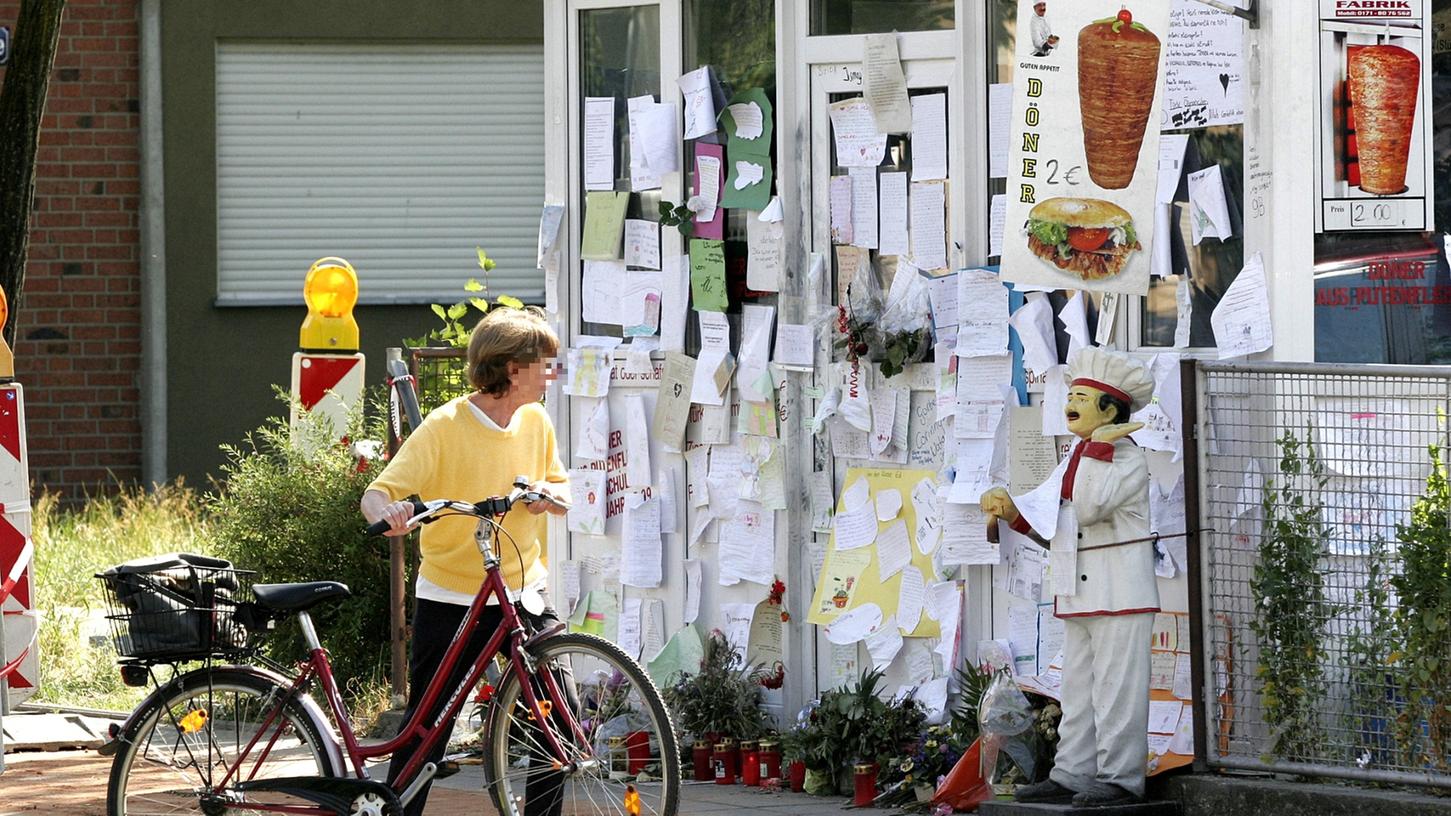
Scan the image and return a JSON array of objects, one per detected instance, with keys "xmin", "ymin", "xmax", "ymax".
[{"xmin": 1196, "ymin": 363, "xmax": 1451, "ymax": 787}]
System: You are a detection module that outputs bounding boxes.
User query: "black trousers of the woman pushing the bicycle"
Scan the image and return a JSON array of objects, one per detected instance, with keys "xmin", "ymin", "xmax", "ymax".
[{"xmin": 387, "ymin": 598, "xmax": 575, "ymax": 816}]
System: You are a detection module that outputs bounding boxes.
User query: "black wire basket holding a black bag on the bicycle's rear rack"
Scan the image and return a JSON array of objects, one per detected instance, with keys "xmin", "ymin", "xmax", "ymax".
[{"xmin": 96, "ymin": 553, "xmax": 252, "ymax": 661}]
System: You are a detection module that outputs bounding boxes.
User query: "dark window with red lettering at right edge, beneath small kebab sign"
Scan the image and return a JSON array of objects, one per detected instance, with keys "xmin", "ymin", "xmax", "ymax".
[{"xmin": 1315, "ymin": 19, "xmax": 1451, "ymax": 364}]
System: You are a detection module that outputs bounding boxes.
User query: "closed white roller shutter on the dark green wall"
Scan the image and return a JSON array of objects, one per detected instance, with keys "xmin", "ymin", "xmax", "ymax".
[{"xmin": 216, "ymin": 42, "xmax": 544, "ymax": 305}]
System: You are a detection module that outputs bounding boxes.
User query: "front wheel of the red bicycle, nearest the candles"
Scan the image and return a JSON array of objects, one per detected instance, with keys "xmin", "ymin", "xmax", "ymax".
[{"xmin": 486, "ymin": 633, "xmax": 681, "ymax": 816}]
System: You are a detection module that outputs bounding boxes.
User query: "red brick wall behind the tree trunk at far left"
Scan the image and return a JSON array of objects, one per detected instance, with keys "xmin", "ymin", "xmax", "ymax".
[{"xmin": 0, "ymin": 0, "xmax": 141, "ymax": 498}]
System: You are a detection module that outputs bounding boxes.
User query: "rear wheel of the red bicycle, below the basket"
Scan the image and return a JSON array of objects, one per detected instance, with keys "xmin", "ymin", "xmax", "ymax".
[{"xmin": 106, "ymin": 668, "xmax": 337, "ymax": 816}]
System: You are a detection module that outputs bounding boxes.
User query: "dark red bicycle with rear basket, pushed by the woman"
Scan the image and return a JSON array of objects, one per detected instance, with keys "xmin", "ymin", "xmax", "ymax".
[{"xmin": 102, "ymin": 476, "xmax": 681, "ymax": 816}]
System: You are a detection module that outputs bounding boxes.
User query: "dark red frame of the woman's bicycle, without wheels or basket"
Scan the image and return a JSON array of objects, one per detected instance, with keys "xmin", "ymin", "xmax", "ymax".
[{"xmin": 216, "ymin": 518, "xmax": 589, "ymax": 816}]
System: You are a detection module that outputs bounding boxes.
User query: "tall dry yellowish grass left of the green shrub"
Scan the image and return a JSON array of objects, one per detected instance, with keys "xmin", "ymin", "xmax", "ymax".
[{"xmin": 32, "ymin": 485, "xmax": 210, "ymax": 710}]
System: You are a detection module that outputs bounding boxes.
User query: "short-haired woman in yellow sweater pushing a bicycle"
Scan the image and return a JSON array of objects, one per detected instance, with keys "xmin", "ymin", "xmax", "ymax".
[{"xmin": 361, "ymin": 308, "xmax": 569, "ymax": 816}]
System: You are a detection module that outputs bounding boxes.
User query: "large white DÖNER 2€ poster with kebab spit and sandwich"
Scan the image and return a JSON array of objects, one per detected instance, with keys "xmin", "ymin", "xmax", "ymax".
[{"xmin": 1003, "ymin": 0, "xmax": 1170, "ymax": 295}]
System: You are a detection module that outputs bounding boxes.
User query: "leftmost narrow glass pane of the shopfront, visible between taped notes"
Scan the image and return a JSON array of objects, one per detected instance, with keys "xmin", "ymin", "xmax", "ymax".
[{"xmin": 576, "ymin": 6, "xmax": 660, "ymax": 337}]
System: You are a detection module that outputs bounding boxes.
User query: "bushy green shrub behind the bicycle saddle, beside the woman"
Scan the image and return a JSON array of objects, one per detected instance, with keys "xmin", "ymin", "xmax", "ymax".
[{"xmin": 207, "ymin": 393, "xmax": 389, "ymax": 688}]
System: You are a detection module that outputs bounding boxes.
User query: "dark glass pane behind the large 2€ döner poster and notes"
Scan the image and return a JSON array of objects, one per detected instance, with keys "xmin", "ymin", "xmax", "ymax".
[{"xmin": 988, "ymin": 0, "xmax": 1245, "ymax": 348}]
